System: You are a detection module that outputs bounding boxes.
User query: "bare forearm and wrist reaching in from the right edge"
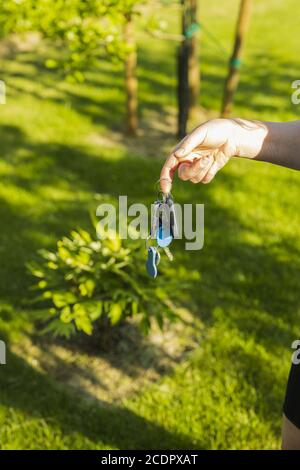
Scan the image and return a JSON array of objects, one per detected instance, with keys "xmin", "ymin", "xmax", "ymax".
[{"xmin": 234, "ymin": 119, "xmax": 300, "ymax": 170}]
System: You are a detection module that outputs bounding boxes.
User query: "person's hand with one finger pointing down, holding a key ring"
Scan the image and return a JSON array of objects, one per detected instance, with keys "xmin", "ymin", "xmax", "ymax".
[{"xmin": 160, "ymin": 119, "xmax": 268, "ymax": 193}]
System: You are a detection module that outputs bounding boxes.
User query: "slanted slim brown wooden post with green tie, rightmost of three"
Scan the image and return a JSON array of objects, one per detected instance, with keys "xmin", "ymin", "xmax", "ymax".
[{"xmin": 221, "ymin": 0, "xmax": 252, "ymax": 117}]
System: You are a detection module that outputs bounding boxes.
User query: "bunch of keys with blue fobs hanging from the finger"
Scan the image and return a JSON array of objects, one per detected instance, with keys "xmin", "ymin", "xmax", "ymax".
[{"xmin": 146, "ymin": 180, "xmax": 178, "ymax": 278}]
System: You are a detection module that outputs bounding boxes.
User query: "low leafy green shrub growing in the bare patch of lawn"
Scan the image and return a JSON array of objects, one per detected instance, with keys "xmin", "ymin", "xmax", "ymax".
[{"xmin": 29, "ymin": 224, "xmax": 176, "ymax": 337}]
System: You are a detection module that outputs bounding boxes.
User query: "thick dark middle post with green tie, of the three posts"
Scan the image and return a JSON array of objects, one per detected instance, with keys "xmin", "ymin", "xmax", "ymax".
[{"xmin": 177, "ymin": 0, "xmax": 200, "ymax": 138}]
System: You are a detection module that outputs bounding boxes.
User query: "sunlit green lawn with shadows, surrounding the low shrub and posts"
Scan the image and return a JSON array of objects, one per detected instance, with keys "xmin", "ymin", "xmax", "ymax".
[{"xmin": 0, "ymin": 0, "xmax": 300, "ymax": 449}]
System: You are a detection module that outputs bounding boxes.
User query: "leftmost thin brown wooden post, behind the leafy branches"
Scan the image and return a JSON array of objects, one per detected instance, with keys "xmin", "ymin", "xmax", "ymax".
[{"xmin": 124, "ymin": 13, "xmax": 138, "ymax": 135}]
